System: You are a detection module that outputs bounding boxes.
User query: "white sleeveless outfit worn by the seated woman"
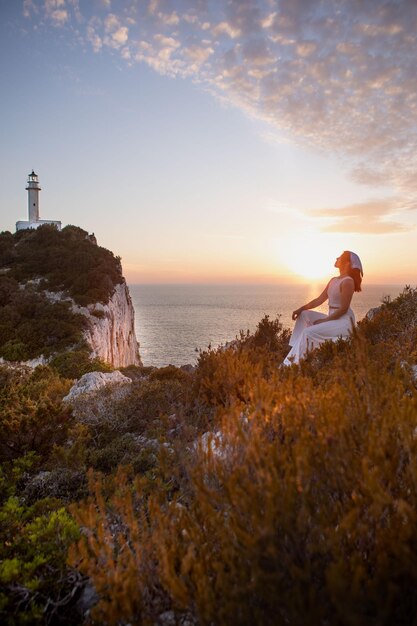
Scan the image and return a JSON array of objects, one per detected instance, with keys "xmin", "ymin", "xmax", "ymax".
[{"xmin": 284, "ymin": 276, "xmax": 355, "ymax": 365}]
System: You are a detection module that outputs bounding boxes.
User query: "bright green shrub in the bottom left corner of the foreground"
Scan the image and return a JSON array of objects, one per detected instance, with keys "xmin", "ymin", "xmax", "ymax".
[{"xmin": 0, "ymin": 455, "xmax": 82, "ymax": 626}]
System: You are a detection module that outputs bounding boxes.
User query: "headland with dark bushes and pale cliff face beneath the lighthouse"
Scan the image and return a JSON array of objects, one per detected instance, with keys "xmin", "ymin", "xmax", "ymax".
[{"xmin": 0, "ymin": 225, "xmax": 140, "ymax": 368}]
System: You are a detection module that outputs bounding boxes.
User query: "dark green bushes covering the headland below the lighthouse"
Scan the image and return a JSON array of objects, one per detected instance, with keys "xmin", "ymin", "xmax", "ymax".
[{"xmin": 0, "ymin": 225, "xmax": 122, "ymax": 366}]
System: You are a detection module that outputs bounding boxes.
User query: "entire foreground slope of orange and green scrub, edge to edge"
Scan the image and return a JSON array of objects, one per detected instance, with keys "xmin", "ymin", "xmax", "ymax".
[{"xmin": 0, "ymin": 288, "xmax": 417, "ymax": 626}]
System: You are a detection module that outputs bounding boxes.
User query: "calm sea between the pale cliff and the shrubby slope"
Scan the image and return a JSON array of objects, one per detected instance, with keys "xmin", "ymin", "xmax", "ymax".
[{"xmin": 129, "ymin": 284, "xmax": 404, "ymax": 367}]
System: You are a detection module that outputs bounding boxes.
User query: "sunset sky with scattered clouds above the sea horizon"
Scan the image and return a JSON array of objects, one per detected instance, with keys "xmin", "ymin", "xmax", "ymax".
[{"xmin": 0, "ymin": 0, "xmax": 417, "ymax": 285}]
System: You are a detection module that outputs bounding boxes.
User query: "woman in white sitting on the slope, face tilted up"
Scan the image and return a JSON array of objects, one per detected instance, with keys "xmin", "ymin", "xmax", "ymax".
[{"xmin": 284, "ymin": 250, "xmax": 363, "ymax": 365}]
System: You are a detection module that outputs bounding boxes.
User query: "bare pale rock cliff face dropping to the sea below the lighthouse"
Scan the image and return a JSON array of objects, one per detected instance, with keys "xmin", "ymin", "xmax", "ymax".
[{"xmin": 73, "ymin": 282, "xmax": 142, "ymax": 367}]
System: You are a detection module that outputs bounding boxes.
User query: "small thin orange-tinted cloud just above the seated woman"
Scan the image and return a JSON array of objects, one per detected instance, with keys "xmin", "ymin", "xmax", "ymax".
[{"xmin": 309, "ymin": 198, "xmax": 408, "ymax": 234}]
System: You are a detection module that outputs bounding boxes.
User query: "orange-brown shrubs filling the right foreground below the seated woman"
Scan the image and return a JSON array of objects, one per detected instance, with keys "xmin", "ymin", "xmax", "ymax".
[{"xmin": 71, "ymin": 310, "xmax": 417, "ymax": 626}]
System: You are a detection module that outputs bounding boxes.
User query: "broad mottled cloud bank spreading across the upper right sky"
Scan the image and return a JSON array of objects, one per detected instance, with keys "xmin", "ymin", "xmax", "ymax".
[{"xmin": 23, "ymin": 0, "xmax": 417, "ymax": 232}]
